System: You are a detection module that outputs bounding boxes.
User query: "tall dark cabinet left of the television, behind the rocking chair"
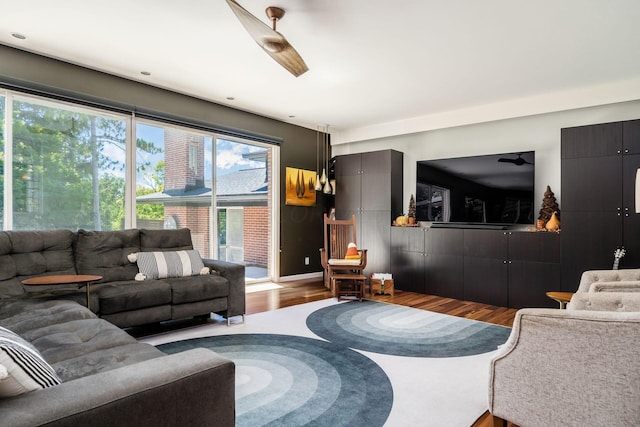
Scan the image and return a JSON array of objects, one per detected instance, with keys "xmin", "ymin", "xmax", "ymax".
[{"xmin": 335, "ymin": 150, "xmax": 403, "ymax": 274}]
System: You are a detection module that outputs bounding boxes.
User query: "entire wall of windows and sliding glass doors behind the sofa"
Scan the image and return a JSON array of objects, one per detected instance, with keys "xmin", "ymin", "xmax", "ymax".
[{"xmin": 0, "ymin": 91, "xmax": 276, "ymax": 281}]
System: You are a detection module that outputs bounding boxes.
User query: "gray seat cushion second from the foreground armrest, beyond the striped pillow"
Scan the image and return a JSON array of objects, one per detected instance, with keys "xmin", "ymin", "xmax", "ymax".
[{"xmin": 21, "ymin": 319, "xmax": 136, "ymax": 364}]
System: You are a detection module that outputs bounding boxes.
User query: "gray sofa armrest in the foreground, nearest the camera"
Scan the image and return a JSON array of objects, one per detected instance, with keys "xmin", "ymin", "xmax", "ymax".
[{"xmin": 0, "ymin": 348, "xmax": 235, "ymax": 426}]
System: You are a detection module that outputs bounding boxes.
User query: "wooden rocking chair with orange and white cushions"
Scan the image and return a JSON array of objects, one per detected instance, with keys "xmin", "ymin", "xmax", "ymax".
[{"xmin": 320, "ymin": 214, "xmax": 367, "ymax": 300}]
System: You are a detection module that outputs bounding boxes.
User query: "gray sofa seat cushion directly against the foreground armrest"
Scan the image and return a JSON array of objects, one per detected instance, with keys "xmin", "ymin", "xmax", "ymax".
[{"xmin": 52, "ymin": 342, "xmax": 165, "ymax": 381}]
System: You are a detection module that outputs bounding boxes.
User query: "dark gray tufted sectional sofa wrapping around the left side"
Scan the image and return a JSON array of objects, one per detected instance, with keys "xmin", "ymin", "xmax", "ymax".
[{"xmin": 0, "ymin": 230, "xmax": 245, "ymax": 426}]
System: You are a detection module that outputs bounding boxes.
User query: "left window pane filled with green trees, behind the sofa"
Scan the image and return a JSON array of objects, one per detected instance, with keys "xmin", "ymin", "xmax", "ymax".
[{"xmin": 7, "ymin": 96, "xmax": 126, "ymax": 230}]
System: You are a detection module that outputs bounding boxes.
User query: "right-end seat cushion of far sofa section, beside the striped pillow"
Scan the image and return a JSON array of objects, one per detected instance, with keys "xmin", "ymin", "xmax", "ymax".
[{"xmin": 168, "ymin": 275, "xmax": 229, "ymax": 304}]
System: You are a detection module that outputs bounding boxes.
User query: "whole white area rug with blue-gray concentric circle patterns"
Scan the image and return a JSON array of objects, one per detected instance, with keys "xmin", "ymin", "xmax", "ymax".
[{"xmin": 141, "ymin": 300, "xmax": 510, "ymax": 427}]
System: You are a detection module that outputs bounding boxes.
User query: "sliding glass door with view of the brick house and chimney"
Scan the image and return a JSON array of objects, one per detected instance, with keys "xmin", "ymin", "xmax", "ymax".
[{"xmin": 135, "ymin": 121, "xmax": 274, "ymax": 282}]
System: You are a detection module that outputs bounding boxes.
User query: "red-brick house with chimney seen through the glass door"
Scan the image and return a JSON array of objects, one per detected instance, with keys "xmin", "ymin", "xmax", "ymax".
[{"xmin": 138, "ymin": 128, "xmax": 271, "ymax": 273}]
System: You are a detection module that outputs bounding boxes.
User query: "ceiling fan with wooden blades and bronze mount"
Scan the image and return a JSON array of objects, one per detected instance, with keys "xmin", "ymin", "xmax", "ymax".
[{"xmin": 226, "ymin": 0, "xmax": 309, "ymax": 77}]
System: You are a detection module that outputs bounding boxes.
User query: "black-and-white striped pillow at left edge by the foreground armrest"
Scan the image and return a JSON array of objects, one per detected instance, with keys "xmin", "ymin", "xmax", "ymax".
[{"xmin": 0, "ymin": 326, "xmax": 62, "ymax": 398}]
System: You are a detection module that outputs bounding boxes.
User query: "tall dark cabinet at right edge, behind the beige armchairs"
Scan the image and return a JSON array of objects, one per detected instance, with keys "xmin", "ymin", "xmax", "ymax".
[{"xmin": 561, "ymin": 120, "xmax": 640, "ymax": 292}]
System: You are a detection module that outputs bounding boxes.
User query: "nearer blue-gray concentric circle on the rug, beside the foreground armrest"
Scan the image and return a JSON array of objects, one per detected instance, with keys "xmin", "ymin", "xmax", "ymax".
[{"xmin": 158, "ymin": 334, "xmax": 393, "ymax": 426}]
